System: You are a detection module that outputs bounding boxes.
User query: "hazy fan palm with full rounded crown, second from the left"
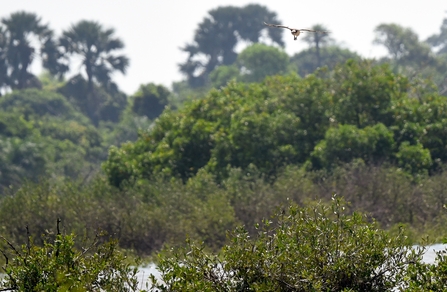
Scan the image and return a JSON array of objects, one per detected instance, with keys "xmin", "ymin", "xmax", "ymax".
[{"xmin": 60, "ymin": 20, "xmax": 129, "ymax": 92}]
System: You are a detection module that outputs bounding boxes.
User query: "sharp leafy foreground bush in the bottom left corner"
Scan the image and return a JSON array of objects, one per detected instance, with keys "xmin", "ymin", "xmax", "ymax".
[{"xmin": 0, "ymin": 222, "xmax": 138, "ymax": 292}]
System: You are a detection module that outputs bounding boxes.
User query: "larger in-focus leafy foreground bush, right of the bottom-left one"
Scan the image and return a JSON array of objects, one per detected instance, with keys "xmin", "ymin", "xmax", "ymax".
[{"xmin": 152, "ymin": 197, "xmax": 422, "ymax": 291}]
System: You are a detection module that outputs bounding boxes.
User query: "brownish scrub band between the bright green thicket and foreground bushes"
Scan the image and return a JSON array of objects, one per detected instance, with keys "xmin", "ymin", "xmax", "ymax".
[{"xmin": 0, "ymin": 163, "xmax": 447, "ymax": 262}]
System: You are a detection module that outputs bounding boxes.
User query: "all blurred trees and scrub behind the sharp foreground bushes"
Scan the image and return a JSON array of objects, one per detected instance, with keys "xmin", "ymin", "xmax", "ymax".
[{"xmin": 0, "ymin": 4, "xmax": 447, "ymax": 255}]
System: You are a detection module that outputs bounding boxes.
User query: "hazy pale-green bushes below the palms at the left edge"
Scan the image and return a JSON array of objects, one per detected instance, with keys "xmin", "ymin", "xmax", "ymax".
[{"xmin": 0, "ymin": 89, "xmax": 105, "ymax": 192}]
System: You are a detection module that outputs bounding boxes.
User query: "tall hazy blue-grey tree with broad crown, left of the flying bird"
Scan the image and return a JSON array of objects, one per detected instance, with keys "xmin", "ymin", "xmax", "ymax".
[{"xmin": 180, "ymin": 4, "xmax": 284, "ymax": 87}]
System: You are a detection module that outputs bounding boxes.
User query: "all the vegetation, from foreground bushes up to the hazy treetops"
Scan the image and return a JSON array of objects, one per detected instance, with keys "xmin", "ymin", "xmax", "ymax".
[{"xmin": 0, "ymin": 4, "xmax": 447, "ymax": 291}]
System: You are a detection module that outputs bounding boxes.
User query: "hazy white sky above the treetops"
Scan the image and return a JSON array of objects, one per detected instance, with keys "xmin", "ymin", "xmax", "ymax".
[{"xmin": 0, "ymin": 0, "xmax": 447, "ymax": 94}]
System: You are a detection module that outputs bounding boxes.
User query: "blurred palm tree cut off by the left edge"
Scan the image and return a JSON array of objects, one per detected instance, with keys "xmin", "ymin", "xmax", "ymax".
[{"xmin": 0, "ymin": 11, "xmax": 52, "ymax": 89}]
